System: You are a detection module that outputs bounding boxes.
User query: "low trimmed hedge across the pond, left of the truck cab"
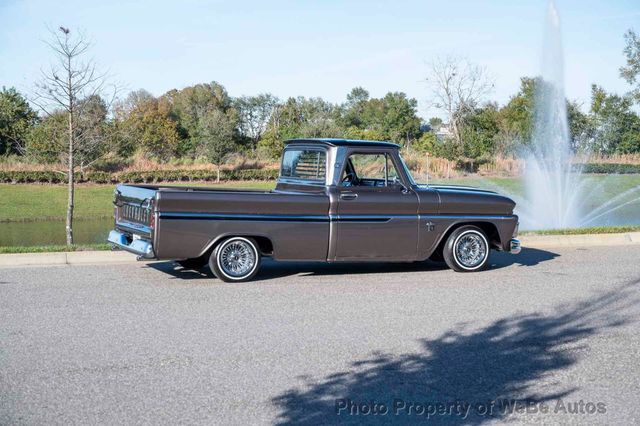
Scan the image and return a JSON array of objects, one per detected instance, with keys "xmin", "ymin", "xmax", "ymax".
[{"xmin": 0, "ymin": 169, "xmax": 278, "ymax": 183}]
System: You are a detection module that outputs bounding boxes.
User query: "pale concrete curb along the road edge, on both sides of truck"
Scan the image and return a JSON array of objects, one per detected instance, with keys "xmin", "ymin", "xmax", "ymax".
[{"xmin": 0, "ymin": 232, "xmax": 640, "ymax": 268}]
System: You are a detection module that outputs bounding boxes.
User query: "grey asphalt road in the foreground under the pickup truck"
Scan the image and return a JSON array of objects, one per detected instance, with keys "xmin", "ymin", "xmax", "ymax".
[{"xmin": 0, "ymin": 246, "xmax": 640, "ymax": 424}]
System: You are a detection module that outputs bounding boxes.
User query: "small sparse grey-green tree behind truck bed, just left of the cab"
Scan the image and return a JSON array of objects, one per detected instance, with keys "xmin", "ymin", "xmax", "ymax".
[{"xmin": 233, "ymin": 93, "xmax": 278, "ymax": 151}]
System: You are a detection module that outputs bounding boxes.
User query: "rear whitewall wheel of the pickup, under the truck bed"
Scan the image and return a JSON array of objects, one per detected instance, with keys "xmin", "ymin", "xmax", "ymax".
[{"xmin": 209, "ymin": 237, "xmax": 260, "ymax": 283}]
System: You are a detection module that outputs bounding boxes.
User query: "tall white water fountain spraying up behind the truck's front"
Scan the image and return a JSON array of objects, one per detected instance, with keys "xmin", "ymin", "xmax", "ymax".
[{"xmin": 514, "ymin": 0, "xmax": 640, "ymax": 229}]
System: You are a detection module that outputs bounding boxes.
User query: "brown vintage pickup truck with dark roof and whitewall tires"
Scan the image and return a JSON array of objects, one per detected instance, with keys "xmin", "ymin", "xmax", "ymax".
[{"xmin": 108, "ymin": 139, "xmax": 520, "ymax": 282}]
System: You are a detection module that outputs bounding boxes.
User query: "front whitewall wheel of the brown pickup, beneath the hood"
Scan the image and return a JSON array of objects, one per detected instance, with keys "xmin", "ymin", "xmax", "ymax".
[{"xmin": 442, "ymin": 225, "xmax": 490, "ymax": 272}]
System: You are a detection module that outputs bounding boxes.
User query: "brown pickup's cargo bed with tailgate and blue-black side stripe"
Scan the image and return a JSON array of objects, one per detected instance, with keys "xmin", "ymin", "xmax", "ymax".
[{"xmin": 115, "ymin": 185, "xmax": 329, "ymax": 260}]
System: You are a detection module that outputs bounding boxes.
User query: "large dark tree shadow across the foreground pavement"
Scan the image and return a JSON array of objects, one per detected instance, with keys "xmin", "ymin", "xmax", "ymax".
[{"xmin": 271, "ymin": 281, "xmax": 640, "ymax": 425}]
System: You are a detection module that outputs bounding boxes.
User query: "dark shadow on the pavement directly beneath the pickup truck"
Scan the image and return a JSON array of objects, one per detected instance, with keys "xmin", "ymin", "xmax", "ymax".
[{"xmin": 149, "ymin": 248, "xmax": 559, "ymax": 281}]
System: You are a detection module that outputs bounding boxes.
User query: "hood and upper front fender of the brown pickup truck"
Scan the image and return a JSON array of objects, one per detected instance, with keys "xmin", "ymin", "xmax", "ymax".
[{"xmin": 421, "ymin": 185, "xmax": 516, "ymax": 215}]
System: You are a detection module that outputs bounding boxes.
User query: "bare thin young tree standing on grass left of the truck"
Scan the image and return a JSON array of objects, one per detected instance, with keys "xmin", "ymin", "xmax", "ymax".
[{"xmin": 32, "ymin": 26, "xmax": 116, "ymax": 245}]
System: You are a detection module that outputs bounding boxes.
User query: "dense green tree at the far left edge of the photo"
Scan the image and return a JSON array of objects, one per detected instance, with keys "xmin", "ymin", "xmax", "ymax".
[{"xmin": 0, "ymin": 87, "xmax": 38, "ymax": 155}]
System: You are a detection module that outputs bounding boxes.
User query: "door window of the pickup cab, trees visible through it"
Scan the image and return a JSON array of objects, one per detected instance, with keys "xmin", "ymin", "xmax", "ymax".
[{"xmin": 342, "ymin": 153, "xmax": 398, "ymax": 186}]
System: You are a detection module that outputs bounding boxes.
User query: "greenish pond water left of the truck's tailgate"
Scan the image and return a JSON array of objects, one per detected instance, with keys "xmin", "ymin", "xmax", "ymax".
[{"xmin": 0, "ymin": 218, "xmax": 113, "ymax": 247}]
